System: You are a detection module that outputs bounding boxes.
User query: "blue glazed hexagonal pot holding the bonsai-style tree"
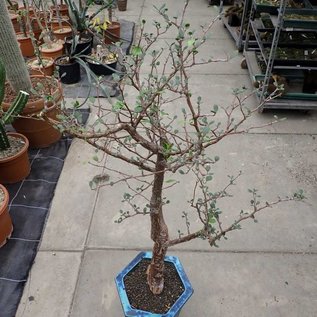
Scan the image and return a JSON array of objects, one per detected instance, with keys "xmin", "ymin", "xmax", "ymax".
[{"xmin": 115, "ymin": 252, "xmax": 194, "ymax": 317}]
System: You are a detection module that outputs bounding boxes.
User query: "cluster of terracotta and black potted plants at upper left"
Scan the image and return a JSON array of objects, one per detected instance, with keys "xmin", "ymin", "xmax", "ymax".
[{"xmin": 7, "ymin": 0, "xmax": 122, "ymax": 84}]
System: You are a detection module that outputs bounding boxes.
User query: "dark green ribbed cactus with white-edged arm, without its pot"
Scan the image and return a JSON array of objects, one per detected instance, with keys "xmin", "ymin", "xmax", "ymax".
[{"xmin": 0, "ymin": 59, "xmax": 29, "ymax": 151}]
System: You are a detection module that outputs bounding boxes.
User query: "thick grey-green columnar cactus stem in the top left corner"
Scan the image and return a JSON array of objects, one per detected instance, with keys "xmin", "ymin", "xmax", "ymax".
[{"xmin": 0, "ymin": 0, "xmax": 31, "ymax": 92}]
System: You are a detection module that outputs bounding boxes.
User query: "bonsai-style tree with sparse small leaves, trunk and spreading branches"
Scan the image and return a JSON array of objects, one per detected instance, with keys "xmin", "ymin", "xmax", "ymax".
[{"xmin": 56, "ymin": 0, "xmax": 304, "ymax": 294}]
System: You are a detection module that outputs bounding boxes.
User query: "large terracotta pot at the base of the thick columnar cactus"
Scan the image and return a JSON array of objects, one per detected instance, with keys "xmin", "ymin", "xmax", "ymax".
[{"xmin": 2, "ymin": 76, "xmax": 62, "ymax": 148}]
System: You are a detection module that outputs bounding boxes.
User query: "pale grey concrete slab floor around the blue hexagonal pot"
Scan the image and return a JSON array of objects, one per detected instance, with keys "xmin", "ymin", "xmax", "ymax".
[{"xmin": 16, "ymin": 0, "xmax": 317, "ymax": 317}]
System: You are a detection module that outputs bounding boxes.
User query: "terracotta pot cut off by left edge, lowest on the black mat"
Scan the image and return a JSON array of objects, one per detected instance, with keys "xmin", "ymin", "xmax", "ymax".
[{"xmin": 0, "ymin": 184, "xmax": 13, "ymax": 248}]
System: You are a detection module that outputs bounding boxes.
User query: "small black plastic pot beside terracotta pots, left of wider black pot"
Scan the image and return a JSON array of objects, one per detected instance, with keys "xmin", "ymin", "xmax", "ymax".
[{"xmin": 54, "ymin": 55, "xmax": 80, "ymax": 84}]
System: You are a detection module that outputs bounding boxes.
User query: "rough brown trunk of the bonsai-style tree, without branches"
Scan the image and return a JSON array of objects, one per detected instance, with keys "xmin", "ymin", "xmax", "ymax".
[{"xmin": 147, "ymin": 153, "xmax": 169, "ymax": 294}]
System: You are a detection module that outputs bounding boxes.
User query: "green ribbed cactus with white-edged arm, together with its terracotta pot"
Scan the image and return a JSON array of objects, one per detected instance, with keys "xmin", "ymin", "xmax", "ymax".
[{"xmin": 0, "ymin": 60, "xmax": 30, "ymax": 183}]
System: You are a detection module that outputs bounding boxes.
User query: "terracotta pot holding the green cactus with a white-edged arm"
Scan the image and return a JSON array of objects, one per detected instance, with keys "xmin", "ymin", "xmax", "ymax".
[{"xmin": 0, "ymin": 132, "xmax": 31, "ymax": 184}]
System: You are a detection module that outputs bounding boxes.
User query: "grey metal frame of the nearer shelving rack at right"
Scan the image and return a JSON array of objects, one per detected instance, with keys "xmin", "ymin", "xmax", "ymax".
[{"xmin": 244, "ymin": 0, "xmax": 317, "ymax": 112}]
